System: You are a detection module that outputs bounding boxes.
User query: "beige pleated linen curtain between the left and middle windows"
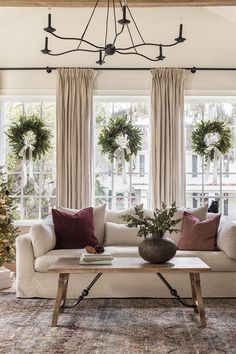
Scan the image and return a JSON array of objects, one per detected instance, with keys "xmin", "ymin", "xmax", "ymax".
[{"xmin": 56, "ymin": 68, "xmax": 96, "ymax": 209}]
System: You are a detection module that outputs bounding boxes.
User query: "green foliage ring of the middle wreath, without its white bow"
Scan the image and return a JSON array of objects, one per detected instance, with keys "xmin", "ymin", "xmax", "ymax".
[{"xmin": 98, "ymin": 116, "xmax": 142, "ymax": 162}]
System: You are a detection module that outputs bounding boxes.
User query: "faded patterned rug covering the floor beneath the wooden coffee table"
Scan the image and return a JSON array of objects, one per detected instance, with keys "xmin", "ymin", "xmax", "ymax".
[{"xmin": 0, "ymin": 289, "xmax": 236, "ymax": 354}]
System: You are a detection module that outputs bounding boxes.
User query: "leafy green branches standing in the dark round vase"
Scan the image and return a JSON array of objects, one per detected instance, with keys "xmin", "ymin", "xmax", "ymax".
[{"xmin": 122, "ymin": 203, "xmax": 181, "ymax": 238}]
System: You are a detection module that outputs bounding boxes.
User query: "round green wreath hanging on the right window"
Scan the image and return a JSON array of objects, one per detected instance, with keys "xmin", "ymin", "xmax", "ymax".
[{"xmin": 192, "ymin": 120, "xmax": 232, "ymax": 161}]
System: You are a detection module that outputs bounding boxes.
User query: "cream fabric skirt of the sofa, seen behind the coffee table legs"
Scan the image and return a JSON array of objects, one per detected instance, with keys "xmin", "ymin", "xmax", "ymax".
[{"xmin": 16, "ymin": 272, "xmax": 236, "ymax": 299}]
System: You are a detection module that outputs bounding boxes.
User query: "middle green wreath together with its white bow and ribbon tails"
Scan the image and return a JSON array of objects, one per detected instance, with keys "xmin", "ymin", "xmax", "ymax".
[{"xmin": 98, "ymin": 116, "xmax": 142, "ymax": 183}]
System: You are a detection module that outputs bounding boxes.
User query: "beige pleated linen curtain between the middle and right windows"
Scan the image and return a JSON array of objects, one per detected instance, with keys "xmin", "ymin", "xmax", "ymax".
[{"xmin": 151, "ymin": 68, "xmax": 185, "ymax": 208}]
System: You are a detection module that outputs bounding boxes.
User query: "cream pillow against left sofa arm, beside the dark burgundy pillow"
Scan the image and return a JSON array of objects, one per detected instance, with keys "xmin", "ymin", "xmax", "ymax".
[{"xmin": 30, "ymin": 224, "xmax": 56, "ymax": 257}]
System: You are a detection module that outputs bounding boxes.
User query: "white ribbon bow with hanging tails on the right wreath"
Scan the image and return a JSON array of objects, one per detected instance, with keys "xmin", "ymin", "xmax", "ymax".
[{"xmin": 204, "ymin": 133, "xmax": 223, "ymax": 184}]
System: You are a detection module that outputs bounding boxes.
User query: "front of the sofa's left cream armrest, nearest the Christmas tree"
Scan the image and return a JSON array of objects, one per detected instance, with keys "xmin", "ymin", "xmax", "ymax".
[{"xmin": 16, "ymin": 234, "xmax": 35, "ymax": 297}]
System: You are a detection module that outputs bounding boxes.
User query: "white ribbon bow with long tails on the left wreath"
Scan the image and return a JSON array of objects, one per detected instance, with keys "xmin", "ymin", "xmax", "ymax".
[{"xmin": 19, "ymin": 130, "xmax": 36, "ymax": 187}]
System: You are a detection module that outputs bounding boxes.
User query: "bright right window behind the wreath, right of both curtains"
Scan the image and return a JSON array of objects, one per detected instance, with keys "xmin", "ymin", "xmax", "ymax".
[{"xmin": 185, "ymin": 97, "xmax": 236, "ymax": 219}]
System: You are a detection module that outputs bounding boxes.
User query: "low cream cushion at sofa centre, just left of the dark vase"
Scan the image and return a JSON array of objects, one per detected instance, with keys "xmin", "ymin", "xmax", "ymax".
[{"xmin": 105, "ymin": 222, "xmax": 142, "ymax": 246}]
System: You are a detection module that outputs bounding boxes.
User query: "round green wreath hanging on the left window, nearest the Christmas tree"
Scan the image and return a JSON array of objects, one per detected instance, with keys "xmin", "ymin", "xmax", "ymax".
[{"xmin": 6, "ymin": 115, "xmax": 52, "ymax": 160}]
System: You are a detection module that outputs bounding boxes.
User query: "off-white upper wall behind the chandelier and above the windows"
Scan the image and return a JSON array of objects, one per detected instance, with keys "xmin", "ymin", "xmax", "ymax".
[{"xmin": 0, "ymin": 7, "xmax": 236, "ymax": 94}]
